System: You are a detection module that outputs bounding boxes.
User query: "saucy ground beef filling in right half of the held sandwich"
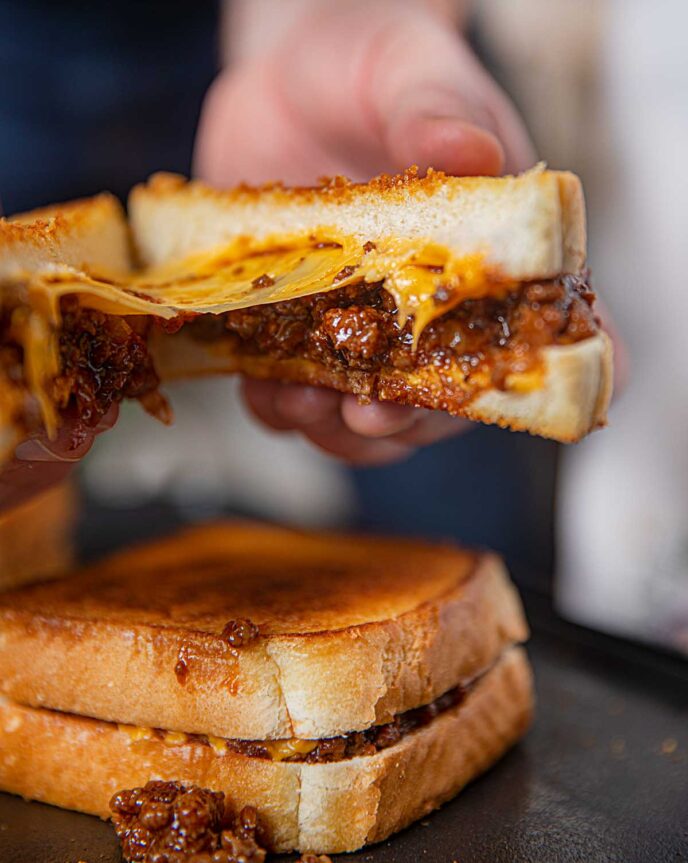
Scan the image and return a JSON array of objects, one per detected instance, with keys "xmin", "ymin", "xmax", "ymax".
[{"xmin": 189, "ymin": 276, "xmax": 598, "ymax": 394}]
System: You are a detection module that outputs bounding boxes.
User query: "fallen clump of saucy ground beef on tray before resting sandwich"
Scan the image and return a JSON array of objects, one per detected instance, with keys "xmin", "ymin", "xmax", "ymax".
[{"xmin": 110, "ymin": 782, "xmax": 266, "ymax": 863}]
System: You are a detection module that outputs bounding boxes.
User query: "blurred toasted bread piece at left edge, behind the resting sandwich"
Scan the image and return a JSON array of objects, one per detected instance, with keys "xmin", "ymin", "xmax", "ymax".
[{"xmin": 0, "ymin": 483, "xmax": 76, "ymax": 590}]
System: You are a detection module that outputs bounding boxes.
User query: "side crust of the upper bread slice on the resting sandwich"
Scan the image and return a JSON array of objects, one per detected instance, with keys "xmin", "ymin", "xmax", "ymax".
[{"xmin": 0, "ymin": 554, "xmax": 528, "ymax": 740}]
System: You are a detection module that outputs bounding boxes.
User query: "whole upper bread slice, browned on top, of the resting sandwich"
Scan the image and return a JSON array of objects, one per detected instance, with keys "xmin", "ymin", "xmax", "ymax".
[{"xmin": 0, "ymin": 524, "xmax": 527, "ymax": 739}]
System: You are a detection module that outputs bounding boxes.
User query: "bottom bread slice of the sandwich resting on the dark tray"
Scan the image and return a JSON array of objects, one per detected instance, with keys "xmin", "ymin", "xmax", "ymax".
[{"xmin": 0, "ymin": 648, "xmax": 533, "ymax": 853}]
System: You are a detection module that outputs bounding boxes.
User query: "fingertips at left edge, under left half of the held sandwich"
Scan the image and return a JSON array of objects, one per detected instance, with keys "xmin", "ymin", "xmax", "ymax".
[{"xmin": 0, "ymin": 405, "xmax": 118, "ymax": 512}]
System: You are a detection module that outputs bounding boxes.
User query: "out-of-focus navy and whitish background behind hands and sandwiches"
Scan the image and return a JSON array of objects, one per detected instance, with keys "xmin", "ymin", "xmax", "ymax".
[{"xmin": 0, "ymin": 0, "xmax": 688, "ymax": 653}]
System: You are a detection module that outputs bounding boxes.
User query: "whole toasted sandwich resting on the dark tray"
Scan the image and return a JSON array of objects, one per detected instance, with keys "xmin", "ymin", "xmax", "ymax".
[{"xmin": 0, "ymin": 524, "xmax": 532, "ymax": 852}]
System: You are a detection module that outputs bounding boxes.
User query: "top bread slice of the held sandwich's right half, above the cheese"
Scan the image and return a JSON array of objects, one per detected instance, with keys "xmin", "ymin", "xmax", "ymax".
[{"xmin": 129, "ymin": 166, "xmax": 585, "ymax": 280}]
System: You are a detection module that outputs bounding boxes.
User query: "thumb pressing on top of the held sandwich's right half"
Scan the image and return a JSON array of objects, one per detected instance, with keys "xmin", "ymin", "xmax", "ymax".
[{"xmin": 361, "ymin": 9, "xmax": 535, "ymax": 175}]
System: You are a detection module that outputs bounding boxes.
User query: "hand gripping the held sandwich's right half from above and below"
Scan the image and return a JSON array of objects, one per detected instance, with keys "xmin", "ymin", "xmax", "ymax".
[{"xmin": 196, "ymin": 0, "xmax": 535, "ymax": 464}]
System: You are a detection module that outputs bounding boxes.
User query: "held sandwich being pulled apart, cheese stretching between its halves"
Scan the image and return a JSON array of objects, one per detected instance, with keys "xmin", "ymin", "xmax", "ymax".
[{"xmin": 0, "ymin": 169, "xmax": 611, "ymax": 462}]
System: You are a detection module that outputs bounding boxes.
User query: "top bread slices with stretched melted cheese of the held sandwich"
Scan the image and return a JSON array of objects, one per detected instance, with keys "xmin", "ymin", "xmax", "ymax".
[{"xmin": 0, "ymin": 168, "xmax": 585, "ymax": 320}]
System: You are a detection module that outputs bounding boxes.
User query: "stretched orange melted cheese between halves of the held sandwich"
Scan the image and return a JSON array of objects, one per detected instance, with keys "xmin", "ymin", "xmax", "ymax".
[{"xmin": 10, "ymin": 228, "xmax": 509, "ymax": 437}]
